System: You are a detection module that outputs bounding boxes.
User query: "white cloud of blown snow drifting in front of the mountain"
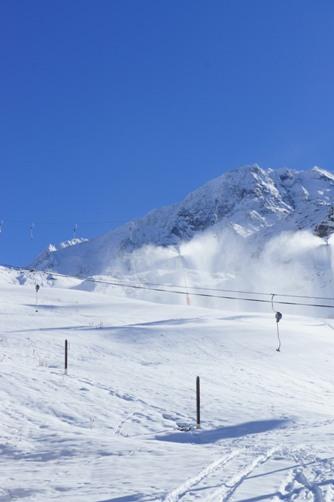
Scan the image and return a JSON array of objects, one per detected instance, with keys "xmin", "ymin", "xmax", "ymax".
[{"xmin": 87, "ymin": 225, "xmax": 334, "ymax": 315}]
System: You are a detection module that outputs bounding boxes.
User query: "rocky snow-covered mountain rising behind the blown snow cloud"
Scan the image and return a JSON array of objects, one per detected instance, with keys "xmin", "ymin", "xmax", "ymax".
[{"xmin": 33, "ymin": 165, "xmax": 334, "ymax": 275}]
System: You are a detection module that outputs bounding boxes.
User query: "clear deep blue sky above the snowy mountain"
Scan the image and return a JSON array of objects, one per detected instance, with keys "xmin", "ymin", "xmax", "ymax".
[{"xmin": 0, "ymin": 0, "xmax": 334, "ymax": 264}]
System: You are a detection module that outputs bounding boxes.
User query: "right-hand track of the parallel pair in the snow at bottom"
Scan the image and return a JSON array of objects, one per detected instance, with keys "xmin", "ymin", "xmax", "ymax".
[{"xmin": 205, "ymin": 448, "xmax": 279, "ymax": 502}]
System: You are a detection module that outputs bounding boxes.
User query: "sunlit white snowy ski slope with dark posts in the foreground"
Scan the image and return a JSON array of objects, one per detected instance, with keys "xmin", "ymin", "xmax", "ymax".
[{"xmin": 0, "ymin": 269, "xmax": 334, "ymax": 502}]
